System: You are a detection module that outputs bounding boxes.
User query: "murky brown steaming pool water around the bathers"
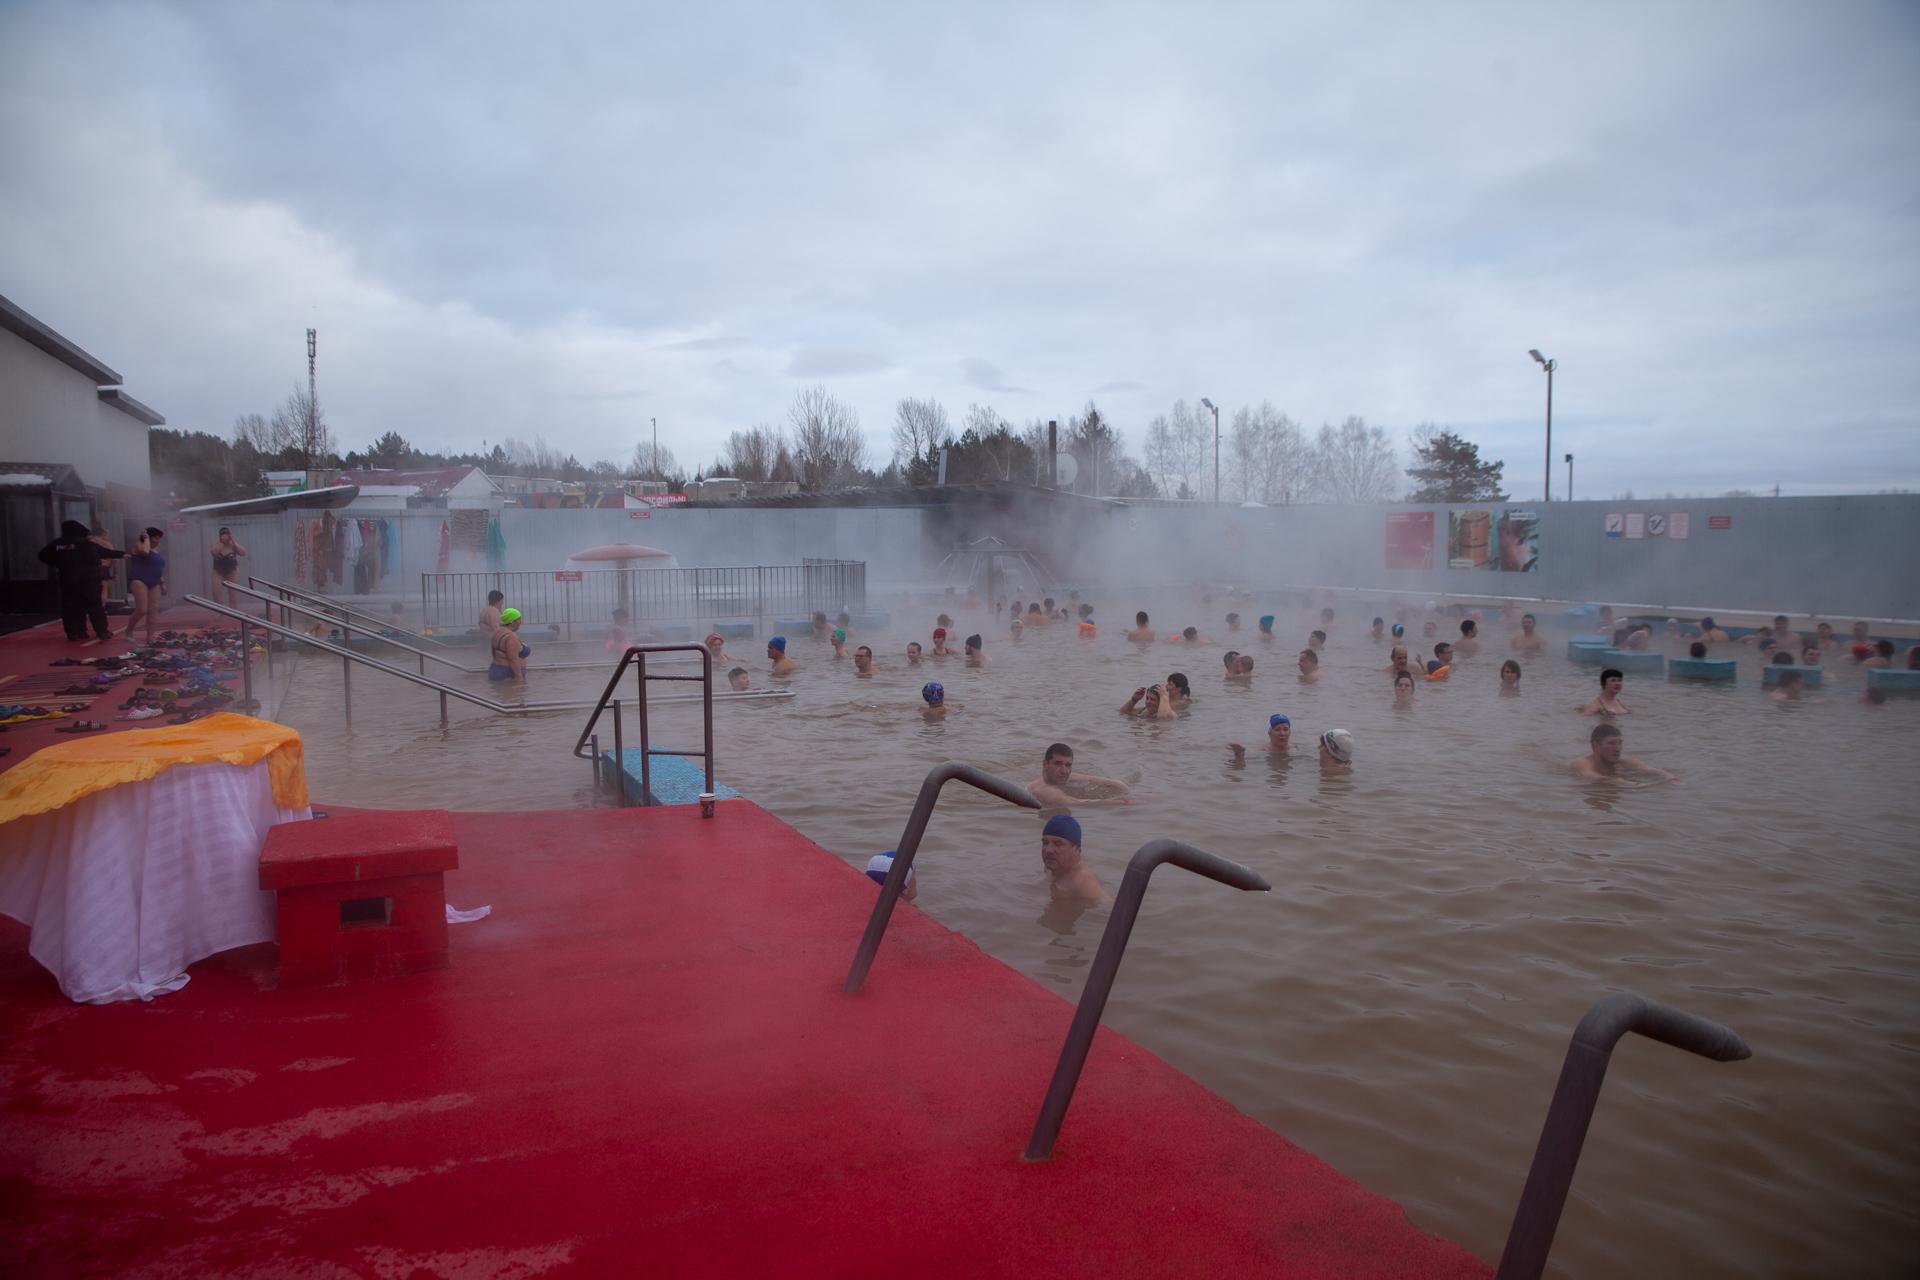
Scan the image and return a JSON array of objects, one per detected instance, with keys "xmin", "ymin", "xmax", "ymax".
[{"xmin": 270, "ymin": 601, "xmax": 1920, "ymax": 1276}]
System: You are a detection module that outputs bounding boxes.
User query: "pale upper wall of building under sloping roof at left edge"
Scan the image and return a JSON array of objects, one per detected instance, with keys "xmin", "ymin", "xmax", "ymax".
[{"xmin": 0, "ymin": 330, "xmax": 154, "ymax": 489}]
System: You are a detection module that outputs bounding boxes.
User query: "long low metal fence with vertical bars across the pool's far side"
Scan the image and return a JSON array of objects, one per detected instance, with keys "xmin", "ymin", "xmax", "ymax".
[{"xmin": 420, "ymin": 560, "xmax": 866, "ymax": 637}]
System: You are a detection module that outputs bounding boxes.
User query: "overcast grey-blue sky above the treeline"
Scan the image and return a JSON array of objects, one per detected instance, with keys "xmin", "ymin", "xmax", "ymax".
[{"xmin": 0, "ymin": 0, "xmax": 1920, "ymax": 497}]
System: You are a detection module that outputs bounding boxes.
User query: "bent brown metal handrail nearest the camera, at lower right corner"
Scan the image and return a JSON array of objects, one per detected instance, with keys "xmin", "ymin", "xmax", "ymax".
[{"xmin": 1496, "ymin": 992, "xmax": 1753, "ymax": 1280}]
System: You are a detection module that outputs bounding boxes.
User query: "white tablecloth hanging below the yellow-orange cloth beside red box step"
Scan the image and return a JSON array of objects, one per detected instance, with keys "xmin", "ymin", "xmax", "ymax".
[{"xmin": 0, "ymin": 760, "xmax": 311, "ymax": 1004}]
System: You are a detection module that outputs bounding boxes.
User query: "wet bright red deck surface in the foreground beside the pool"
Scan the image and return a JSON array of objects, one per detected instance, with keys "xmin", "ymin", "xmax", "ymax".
[{"xmin": 0, "ymin": 800, "xmax": 1486, "ymax": 1278}]
